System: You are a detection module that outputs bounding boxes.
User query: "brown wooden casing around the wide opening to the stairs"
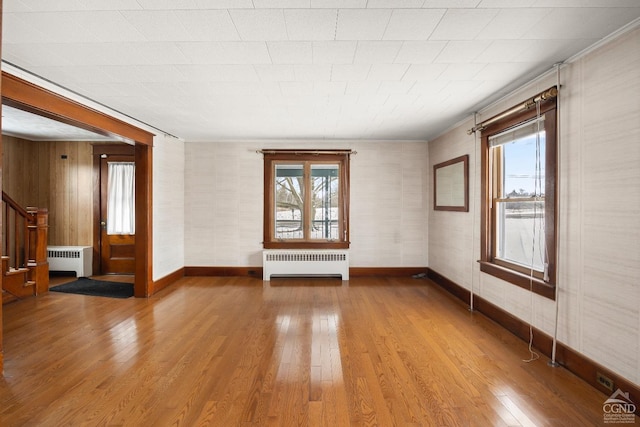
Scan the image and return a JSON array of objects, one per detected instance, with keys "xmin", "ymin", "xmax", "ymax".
[{"xmin": 0, "ymin": 73, "xmax": 154, "ymax": 300}]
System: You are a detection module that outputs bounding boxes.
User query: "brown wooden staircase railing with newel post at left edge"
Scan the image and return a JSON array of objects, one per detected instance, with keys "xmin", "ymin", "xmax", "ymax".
[{"xmin": 2, "ymin": 191, "xmax": 49, "ymax": 305}]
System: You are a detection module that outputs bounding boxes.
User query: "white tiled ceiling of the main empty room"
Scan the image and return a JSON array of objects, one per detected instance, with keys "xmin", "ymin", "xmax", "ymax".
[{"xmin": 2, "ymin": 0, "xmax": 640, "ymax": 141}]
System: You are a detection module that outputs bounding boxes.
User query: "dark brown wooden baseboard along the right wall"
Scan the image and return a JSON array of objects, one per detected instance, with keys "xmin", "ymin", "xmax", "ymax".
[{"xmin": 427, "ymin": 268, "xmax": 640, "ymax": 415}]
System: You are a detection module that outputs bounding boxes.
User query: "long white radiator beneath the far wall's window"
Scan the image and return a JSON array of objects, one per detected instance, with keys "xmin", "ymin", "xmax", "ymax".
[{"xmin": 262, "ymin": 249, "xmax": 349, "ymax": 280}]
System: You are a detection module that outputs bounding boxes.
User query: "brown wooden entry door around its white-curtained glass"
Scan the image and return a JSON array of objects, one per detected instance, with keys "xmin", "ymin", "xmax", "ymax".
[{"xmin": 100, "ymin": 155, "xmax": 136, "ymax": 274}]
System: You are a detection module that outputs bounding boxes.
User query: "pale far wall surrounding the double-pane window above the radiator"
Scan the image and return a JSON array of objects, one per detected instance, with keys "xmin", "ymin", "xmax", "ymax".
[{"xmin": 185, "ymin": 141, "xmax": 429, "ymax": 267}]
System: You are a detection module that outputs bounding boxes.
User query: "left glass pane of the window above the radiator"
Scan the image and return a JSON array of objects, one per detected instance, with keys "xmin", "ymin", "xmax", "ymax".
[{"xmin": 274, "ymin": 164, "xmax": 304, "ymax": 240}]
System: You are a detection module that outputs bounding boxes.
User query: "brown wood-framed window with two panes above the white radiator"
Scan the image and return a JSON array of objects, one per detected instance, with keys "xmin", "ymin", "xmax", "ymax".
[{"xmin": 264, "ymin": 150, "xmax": 350, "ymax": 249}]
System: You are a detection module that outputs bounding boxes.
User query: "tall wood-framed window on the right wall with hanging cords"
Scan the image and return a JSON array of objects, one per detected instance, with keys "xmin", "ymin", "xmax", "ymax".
[{"xmin": 480, "ymin": 98, "xmax": 556, "ymax": 298}]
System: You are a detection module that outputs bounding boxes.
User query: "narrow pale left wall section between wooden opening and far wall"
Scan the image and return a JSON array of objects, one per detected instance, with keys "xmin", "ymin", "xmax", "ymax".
[{"xmin": 152, "ymin": 135, "xmax": 185, "ymax": 280}]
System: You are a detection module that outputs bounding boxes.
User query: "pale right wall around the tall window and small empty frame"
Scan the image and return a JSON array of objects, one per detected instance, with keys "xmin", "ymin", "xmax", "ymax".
[{"xmin": 429, "ymin": 28, "xmax": 640, "ymax": 384}]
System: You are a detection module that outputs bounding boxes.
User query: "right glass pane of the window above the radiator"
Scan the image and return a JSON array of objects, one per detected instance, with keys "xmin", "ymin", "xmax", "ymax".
[{"xmin": 311, "ymin": 164, "xmax": 340, "ymax": 240}]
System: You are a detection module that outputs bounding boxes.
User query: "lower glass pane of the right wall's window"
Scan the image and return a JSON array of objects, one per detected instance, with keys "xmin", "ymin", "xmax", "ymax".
[{"xmin": 496, "ymin": 201, "xmax": 546, "ymax": 272}]
